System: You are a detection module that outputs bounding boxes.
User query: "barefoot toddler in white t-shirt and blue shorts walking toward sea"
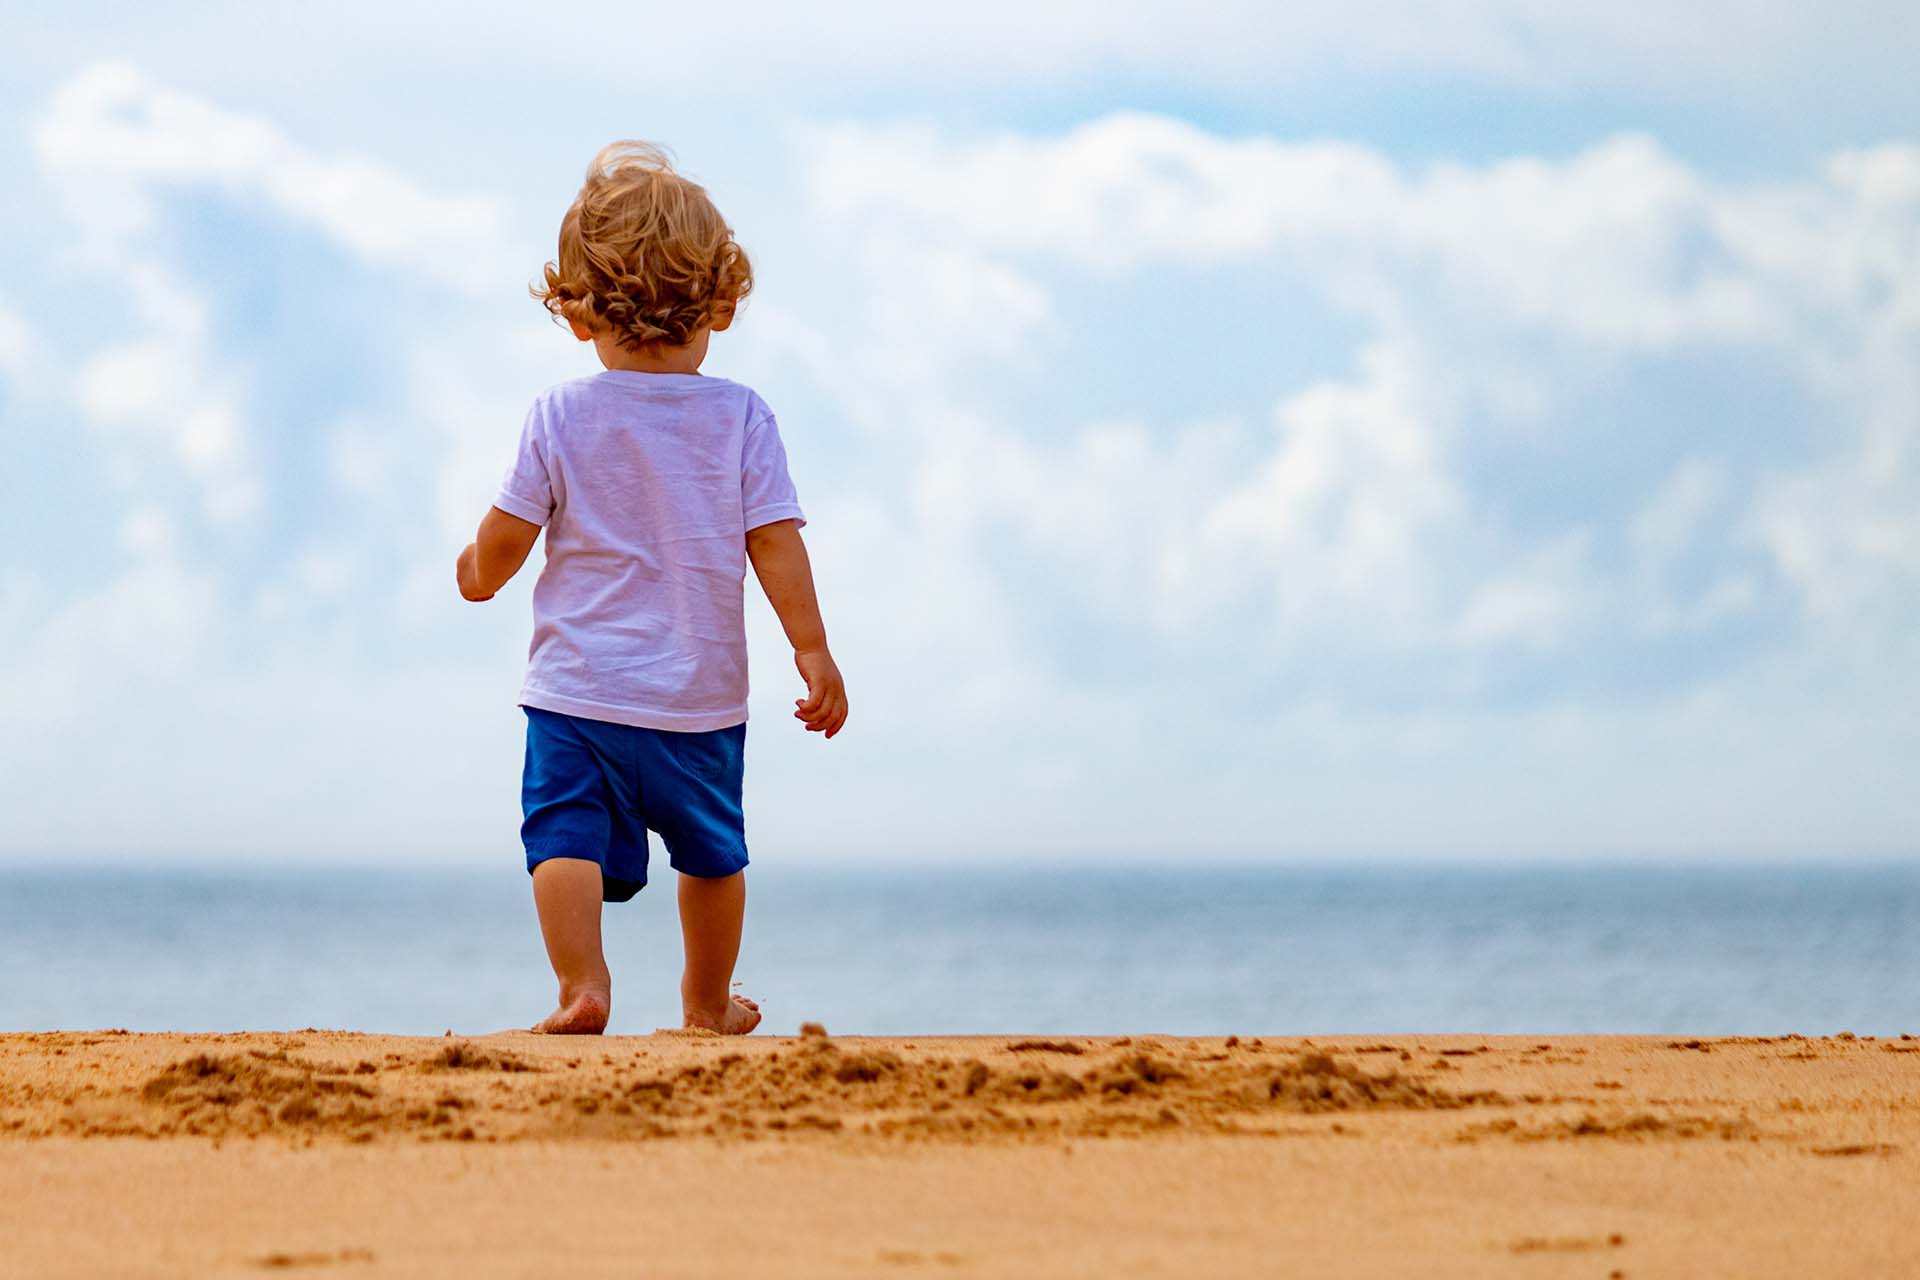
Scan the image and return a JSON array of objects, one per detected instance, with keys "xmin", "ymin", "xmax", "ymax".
[{"xmin": 457, "ymin": 142, "xmax": 847, "ymax": 1034}]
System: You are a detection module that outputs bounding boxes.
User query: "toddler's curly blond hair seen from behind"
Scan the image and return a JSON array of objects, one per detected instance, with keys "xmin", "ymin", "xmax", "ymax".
[{"xmin": 530, "ymin": 140, "xmax": 753, "ymax": 349}]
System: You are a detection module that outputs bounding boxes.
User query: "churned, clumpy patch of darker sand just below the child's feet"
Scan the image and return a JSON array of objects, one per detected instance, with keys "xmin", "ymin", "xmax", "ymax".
[{"xmin": 0, "ymin": 1032, "xmax": 1501, "ymax": 1142}]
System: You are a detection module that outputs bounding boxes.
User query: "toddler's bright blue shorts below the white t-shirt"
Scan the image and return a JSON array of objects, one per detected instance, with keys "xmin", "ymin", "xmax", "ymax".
[{"xmin": 520, "ymin": 706, "xmax": 747, "ymax": 902}]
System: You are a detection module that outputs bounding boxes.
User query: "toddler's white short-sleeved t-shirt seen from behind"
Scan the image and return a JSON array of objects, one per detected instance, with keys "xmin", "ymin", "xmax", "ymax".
[{"xmin": 493, "ymin": 368, "xmax": 806, "ymax": 733}]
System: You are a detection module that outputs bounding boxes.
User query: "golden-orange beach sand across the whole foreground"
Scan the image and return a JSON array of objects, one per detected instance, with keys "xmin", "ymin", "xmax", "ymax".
[{"xmin": 0, "ymin": 1031, "xmax": 1920, "ymax": 1280}]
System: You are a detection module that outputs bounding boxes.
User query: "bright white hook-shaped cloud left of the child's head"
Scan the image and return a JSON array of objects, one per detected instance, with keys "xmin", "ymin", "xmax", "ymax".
[{"xmin": 30, "ymin": 59, "xmax": 560, "ymax": 552}]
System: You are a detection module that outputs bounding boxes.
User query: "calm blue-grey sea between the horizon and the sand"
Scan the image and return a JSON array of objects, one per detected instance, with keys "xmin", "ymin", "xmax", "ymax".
[{"xmin": 0, "ymin": 865, "xmax": 1920, "ymax": 1034}]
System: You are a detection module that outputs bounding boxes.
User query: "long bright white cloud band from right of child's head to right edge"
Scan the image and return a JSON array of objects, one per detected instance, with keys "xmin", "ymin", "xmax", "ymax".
[{"xmin": 812, "ymin": 113, "xmax": 1920, "ymax": 347}]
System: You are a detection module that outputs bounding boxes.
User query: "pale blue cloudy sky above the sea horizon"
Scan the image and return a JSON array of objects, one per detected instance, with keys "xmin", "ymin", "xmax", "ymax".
[{"xmin": 0, "ymin": 0, "xmax": 1920, "ymax": 865}]
